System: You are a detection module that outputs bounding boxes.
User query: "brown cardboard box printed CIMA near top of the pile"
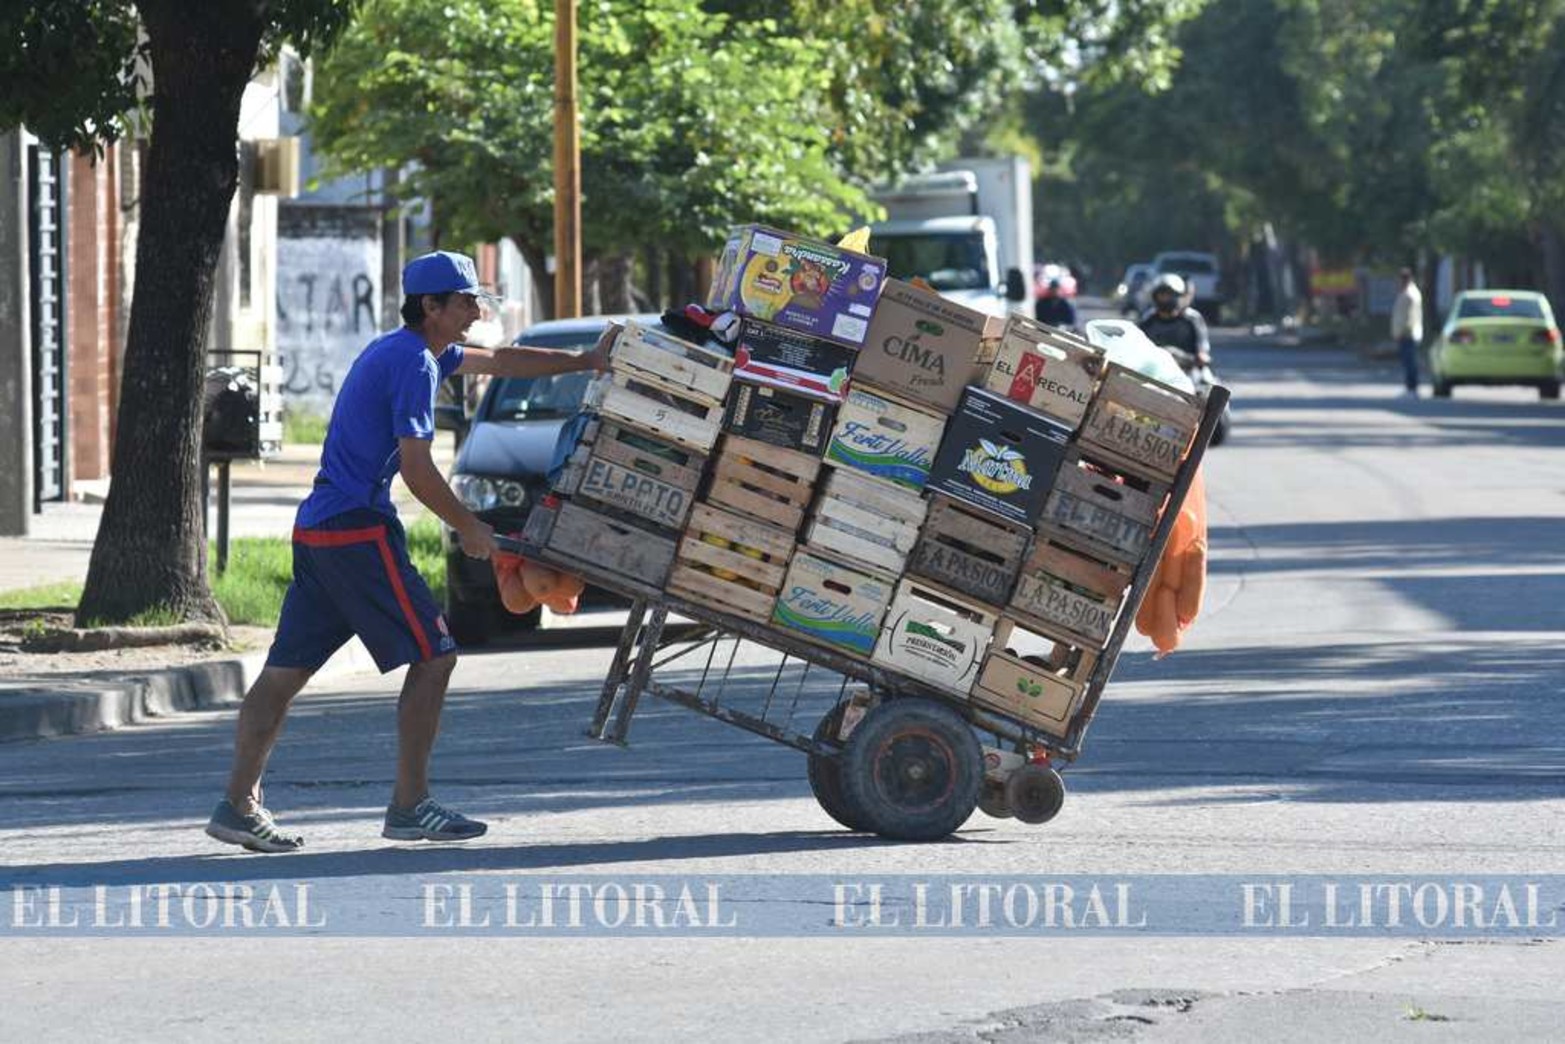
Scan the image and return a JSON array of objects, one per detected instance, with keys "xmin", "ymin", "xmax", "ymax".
[{"xmin": 853, "ymin": 279, "xmax": 1003, "ymax": 413}]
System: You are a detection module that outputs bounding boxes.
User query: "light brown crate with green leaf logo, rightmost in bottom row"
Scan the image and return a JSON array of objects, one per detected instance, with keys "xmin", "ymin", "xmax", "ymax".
[{"xmin": 970, "ymin": 615, "xmax": 1097, "ymax": 737}]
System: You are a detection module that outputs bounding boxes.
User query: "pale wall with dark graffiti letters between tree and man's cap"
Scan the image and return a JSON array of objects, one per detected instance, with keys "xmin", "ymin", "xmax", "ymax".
[{"xmin": 277, "ymin": 207, "xmax": 380, "ymax": 415}]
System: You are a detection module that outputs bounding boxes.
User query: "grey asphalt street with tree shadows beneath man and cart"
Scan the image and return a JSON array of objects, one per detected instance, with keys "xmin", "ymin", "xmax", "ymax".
[{"xmin": 0, "ymin": 314, "xmax": 1565, "ymax": 1041}]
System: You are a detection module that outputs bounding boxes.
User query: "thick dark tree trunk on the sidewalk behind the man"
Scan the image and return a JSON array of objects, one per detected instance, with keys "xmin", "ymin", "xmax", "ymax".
[{"xmin": 77, "ymin": 0, "xmax": 264, "ymax": 625}]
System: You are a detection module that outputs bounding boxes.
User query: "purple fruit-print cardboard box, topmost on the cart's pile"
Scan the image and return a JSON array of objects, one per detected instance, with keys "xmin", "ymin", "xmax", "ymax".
[{"xmin": 706, "ymin": 225, "xmax": 886, "ymax": 347}]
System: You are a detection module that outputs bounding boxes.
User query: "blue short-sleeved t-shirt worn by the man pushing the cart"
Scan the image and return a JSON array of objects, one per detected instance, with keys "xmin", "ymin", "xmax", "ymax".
[{"xmin": 296, "ymin": 327, "xmax": 462, "ymax": 529}]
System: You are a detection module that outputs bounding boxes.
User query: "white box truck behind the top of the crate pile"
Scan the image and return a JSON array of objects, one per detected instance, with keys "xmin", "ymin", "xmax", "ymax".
[{"xmin": 870, "ymin": 157, "xmax": 1033, "ymax": 316}]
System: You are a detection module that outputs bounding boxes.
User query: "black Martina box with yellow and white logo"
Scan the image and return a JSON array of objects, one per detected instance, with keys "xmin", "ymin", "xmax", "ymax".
[{"xmin": 928, "ymin": 388, "xmax": 1070, "ymax": 526}]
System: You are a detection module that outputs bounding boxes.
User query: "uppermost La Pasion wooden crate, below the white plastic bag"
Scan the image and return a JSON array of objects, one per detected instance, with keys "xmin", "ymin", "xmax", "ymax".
[{"xmin": 1080, "ymin": 363, "xmax": 1200, "ymax": 481}]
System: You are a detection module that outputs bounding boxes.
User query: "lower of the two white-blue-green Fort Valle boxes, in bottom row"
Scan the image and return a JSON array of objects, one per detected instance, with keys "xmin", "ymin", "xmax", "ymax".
[{"xmin": 772, "ymin": 548, "xmax": 895, "ymax": 659}]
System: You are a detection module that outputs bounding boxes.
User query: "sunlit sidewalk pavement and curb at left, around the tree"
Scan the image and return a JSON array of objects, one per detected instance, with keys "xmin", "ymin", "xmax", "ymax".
[{"xmin": 0, "ymin": 432, "xmax": 455, "ymax": 743}]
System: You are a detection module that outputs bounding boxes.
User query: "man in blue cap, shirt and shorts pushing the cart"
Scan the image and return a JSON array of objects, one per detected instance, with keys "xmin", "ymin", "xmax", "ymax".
[{"xmin": 207, "ymin": 252, "xmax": 607, "ymax": 851}]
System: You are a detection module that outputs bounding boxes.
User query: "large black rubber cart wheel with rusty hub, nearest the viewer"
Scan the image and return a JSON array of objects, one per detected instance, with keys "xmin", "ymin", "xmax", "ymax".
[{"xmin": 840, "ymin": 698, "xmax": 983, "ymax": 841}]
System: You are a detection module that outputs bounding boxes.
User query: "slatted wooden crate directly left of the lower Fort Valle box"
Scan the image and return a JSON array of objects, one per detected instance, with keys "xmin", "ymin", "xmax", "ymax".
[{"xmin": 668, "ymin": 504, "xmax": 793, "ymax": 623}]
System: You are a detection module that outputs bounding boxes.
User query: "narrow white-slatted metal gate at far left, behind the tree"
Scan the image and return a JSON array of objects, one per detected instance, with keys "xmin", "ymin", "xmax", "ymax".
[{"xmin": 27, "ymin": 146, "xmax": 67, "ymax": 510}]
